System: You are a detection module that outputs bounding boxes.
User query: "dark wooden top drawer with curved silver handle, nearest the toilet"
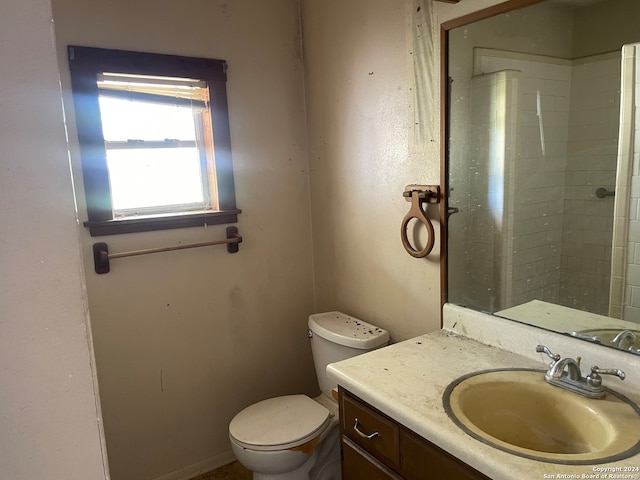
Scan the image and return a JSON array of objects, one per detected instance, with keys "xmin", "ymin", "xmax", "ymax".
[{"xmin": 340, "ymin": 393, "xmax": 399, "ymax": 466}]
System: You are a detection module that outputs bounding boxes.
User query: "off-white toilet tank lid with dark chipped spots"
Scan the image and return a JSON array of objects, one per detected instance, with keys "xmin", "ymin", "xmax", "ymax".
[{"xmin": 309, "ymin": 312, "xmax": 389, "ymax": 350}]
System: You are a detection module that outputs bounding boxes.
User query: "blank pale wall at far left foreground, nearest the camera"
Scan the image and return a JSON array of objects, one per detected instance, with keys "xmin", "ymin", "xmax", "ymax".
[{"xmin": 0, "ymin": 0, "xmax": 106, "ymax": 480}]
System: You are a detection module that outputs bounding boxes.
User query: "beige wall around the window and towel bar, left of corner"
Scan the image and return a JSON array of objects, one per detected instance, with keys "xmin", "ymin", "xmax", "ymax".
[{"xmin": 53, "ymin": 0, "xmax": 318, "ymax": 480}]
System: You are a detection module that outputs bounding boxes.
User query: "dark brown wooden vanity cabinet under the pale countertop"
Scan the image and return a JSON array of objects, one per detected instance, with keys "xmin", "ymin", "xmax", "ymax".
[{"xmin": 338, "ymin": 388, "xmax": 490, "ymax": 480}]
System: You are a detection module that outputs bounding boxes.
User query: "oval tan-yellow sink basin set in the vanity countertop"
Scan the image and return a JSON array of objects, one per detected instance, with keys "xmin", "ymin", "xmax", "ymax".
[{"xmin": 443, "ymin": 369, "xmax": 640, "ymax": 465}]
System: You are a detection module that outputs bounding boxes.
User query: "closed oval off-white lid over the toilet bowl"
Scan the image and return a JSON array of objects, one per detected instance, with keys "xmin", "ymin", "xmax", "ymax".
[{"xmin": 229, "ymin": 395, "xmax": 329, "ymax": 450}]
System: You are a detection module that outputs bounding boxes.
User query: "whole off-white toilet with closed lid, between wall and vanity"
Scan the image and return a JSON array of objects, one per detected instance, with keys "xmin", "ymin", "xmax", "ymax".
[{"xmin": 229, "ymin": 312, "xmax": 389, "ymax": 480}]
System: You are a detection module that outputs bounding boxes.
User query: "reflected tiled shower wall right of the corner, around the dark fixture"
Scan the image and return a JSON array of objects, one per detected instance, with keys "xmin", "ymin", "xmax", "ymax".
[{"xmin": 560, "ymin": 52, "xmax": 620, "ymax": 315}]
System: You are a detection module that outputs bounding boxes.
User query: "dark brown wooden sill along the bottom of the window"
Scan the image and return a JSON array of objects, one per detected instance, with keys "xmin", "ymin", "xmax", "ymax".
[{"xmin": 84, "ymin": 209, "xmax": 242, "ymax": 237}]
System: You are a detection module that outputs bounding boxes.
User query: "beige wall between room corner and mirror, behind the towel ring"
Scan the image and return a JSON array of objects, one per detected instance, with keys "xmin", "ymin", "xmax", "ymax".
[{"xmin": 302, "ymin": 0, "xmax": 440, "ymax": 340}]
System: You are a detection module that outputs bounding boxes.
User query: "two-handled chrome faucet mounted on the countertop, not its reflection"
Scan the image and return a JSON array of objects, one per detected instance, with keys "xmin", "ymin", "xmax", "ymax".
[{"xmin": 536, "ymin": 345, "xmax": 625, "ymax": 398}]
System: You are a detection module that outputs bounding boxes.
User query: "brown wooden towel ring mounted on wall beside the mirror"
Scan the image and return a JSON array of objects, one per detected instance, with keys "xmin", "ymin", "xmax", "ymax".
[{"xmin": 400, "ymin": 185, "xmax": 440, "ymax": 258}]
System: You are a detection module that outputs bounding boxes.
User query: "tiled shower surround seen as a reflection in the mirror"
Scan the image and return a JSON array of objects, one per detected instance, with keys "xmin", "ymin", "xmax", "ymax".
[{"xmin": 449, "ymin": 43, "xmax": 640, "ymax": 318}]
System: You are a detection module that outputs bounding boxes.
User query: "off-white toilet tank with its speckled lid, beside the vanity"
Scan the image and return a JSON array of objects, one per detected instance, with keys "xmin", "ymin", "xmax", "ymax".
[{"xmin": 309, "ymin": 312, "xmax": 389, "ymax": 398}]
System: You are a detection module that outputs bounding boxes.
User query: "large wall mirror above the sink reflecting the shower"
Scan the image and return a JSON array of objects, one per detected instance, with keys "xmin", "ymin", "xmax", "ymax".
[{"xmin": 443, "ymin": 0, "xmax": 640, "ymax": 354}]
